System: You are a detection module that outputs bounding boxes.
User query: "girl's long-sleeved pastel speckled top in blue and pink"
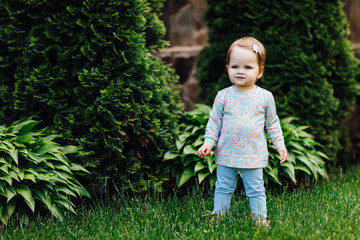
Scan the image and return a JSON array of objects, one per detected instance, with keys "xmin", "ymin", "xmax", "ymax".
[{"xmin": 205, "ymin": 86, "xmax": 285, "ymax": 168}]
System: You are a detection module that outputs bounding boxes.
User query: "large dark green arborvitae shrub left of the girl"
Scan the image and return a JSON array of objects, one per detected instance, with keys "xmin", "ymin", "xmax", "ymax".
[{"xmin": 0, "ymin": 0, "xmax": 181, "ymax": 192}]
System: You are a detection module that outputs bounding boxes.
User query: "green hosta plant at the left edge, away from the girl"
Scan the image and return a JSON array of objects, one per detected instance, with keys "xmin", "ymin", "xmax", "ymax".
[{"xmin": 0, "ymin": 118, "xmax": 90, "ymax": 224}]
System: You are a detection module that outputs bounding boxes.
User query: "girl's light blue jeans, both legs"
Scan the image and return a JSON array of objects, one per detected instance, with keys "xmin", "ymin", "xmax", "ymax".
[{"xmin": 214, "ymin": 165, "xmax": 267, "ymax": 218}]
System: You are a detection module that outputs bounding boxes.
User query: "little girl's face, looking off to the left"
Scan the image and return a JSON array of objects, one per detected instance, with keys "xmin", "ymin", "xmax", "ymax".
[{"xmin": 226, "ymin": 46, "xmax": 264, "ymax": 93}]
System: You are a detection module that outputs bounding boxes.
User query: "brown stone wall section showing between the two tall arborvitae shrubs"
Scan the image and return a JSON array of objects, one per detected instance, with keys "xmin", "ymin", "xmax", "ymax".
[{"xmin": 158, "ymin": 0, "xmax": 208, "ymax": 110}]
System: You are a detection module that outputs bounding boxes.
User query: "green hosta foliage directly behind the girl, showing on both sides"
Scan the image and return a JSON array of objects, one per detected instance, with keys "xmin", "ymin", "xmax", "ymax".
[{"xmin": 164, "ymin": 104, "xmax": 327, "ymax": 187}]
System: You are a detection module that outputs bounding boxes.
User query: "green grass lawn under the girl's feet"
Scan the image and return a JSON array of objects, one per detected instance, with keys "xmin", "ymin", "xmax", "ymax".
[{"xmin": 0, "ymin": 166, "xmax": 360, "ymax": 239}]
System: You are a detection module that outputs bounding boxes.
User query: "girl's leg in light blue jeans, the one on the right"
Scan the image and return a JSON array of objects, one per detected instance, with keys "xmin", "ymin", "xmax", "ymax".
[{"xmin": 239, "ymin": 168, "xmax": 267, "ymax": 218}]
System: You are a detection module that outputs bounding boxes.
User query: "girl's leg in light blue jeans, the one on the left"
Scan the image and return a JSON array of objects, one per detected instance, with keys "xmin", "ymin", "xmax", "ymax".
[{"xmin": 214, "ymin": 165, "xmax": 237, "ymax": 214}]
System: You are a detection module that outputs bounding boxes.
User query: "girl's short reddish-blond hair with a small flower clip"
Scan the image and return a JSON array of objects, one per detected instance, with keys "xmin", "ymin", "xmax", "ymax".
[{"xmin": 226, "ymin": 37, "xmax": 266, "ymax": 67}]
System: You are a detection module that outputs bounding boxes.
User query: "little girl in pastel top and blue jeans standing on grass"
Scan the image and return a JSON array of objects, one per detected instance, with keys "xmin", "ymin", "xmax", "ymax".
[{"xmin": 198, "ymin": 37, "xmax": 287, "ymax": 227}]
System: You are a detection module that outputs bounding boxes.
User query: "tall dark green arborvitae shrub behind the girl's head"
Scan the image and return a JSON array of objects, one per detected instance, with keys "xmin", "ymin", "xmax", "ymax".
[{"xmin": 198, "ymin": 0, "xmax": 359, "ymax": 163}]
